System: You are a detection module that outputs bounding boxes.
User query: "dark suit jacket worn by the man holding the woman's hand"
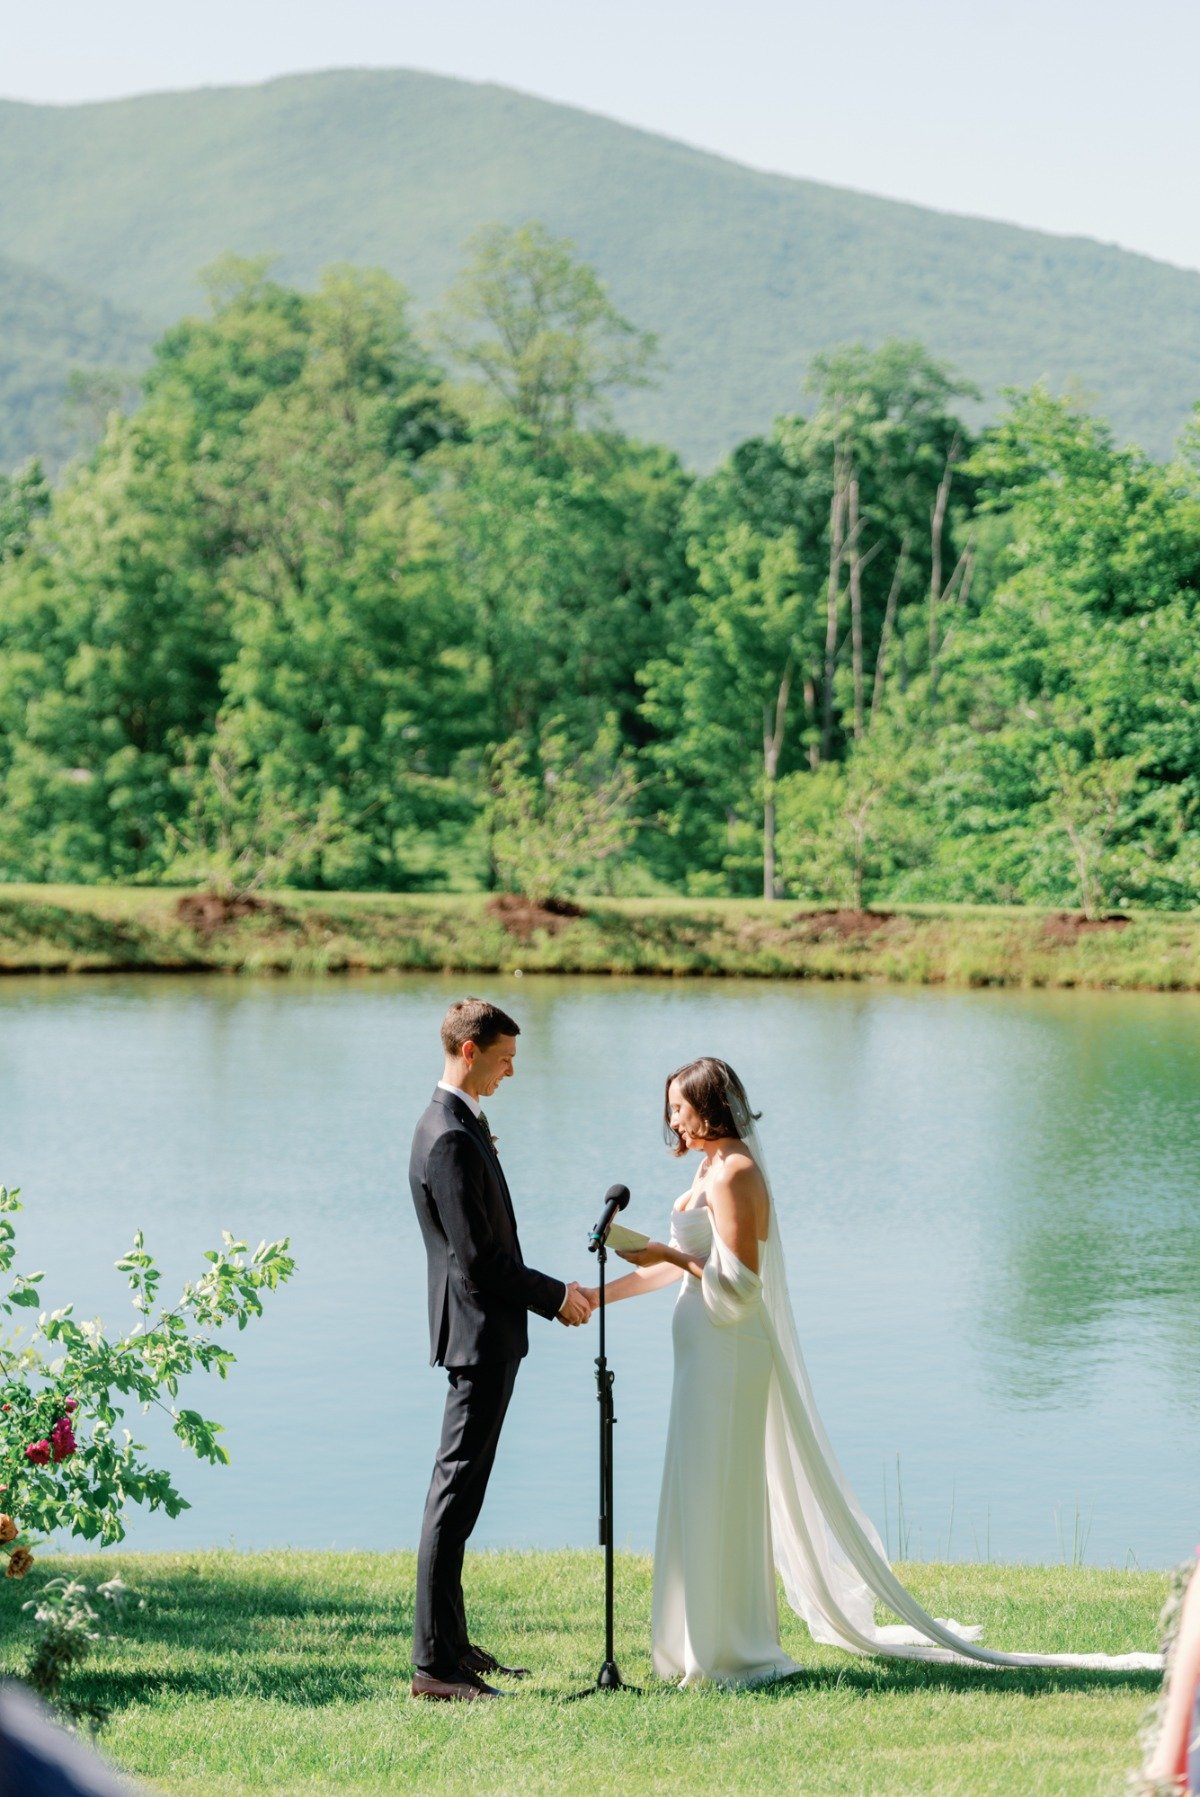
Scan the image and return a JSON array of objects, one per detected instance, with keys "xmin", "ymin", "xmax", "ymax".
[{"xmin": 408, "ymin": 1087, "xmax": 566, "ymax": 1366}]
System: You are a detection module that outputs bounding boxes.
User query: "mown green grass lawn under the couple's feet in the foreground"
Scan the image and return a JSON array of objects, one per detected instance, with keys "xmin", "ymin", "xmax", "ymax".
[{"xmin": 0, "ymin": 1553, "xmax": 1166, "ymax": 1797}]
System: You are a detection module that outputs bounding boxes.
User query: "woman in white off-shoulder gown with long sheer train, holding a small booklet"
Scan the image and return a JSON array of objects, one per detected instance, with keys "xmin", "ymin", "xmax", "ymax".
[{"xmin": 589, "ymin": 1055, "xmax": 1162, "ymax": 1686}]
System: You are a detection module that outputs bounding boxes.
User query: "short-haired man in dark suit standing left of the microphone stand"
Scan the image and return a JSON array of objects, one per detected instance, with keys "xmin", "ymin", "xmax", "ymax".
[{"xmin": 408, "ymin": 999, "xmax": 591, "ymax": 1702}]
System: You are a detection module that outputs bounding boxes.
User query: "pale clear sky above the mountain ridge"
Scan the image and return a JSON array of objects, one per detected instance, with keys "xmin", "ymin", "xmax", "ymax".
[{"xmin": 9, "ymin": 0, "xmax": 1200, "ymax": 268}]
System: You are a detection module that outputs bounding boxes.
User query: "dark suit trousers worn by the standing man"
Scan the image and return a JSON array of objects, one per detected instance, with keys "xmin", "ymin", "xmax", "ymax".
[{"xmin": 413, "ymin": 1360, "xmax": 521, "ymax": 1678}]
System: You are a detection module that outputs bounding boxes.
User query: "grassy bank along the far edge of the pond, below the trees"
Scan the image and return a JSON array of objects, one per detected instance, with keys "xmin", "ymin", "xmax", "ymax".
[{"xmin": 0, "ymin": 886, "xmax": 1200, "ymax": 992}]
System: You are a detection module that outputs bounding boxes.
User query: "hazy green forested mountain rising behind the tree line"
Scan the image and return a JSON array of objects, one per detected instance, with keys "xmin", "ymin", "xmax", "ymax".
[{"xmin": 0, "ymin": 70, "xmax": 1200, "ymax": 465}]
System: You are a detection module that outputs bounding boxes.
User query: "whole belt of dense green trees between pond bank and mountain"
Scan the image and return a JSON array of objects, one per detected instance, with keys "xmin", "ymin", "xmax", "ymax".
[{"xmin": 0, "ymin": 226, "xmax": 1200, "ymax": 913}]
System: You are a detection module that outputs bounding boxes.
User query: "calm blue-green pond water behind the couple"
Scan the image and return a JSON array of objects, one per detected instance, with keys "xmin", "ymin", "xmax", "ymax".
[{"xmin": 0, "ymin": 976, "xmax": 1200, "ymax": 1567}]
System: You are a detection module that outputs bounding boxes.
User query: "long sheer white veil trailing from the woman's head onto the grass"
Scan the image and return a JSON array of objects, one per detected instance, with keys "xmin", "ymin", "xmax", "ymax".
[{"xmin": 722, "ymin": 1093, "xmax": 1162, "ymax": 1671}]
